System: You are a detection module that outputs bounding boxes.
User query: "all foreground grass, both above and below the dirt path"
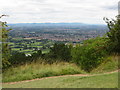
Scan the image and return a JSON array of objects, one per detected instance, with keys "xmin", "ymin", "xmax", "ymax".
[{"xmin": 3, "ymin": 56, "xmax": 118, "ymax": 88}]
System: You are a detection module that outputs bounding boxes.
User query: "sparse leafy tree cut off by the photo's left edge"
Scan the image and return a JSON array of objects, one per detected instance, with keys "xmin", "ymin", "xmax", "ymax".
[{"xmin": 0, "ymin": 15, "xmax": 10, "ymax": 68}]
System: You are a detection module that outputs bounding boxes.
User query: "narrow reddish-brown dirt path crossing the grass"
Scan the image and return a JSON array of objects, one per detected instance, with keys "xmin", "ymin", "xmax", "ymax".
[{"xmin": 2, "ymin": 70, "xmax": 119, "ymax": 84}]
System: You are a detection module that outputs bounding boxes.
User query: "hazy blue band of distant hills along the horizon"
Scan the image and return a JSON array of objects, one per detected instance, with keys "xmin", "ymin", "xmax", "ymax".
[{"xmin": 8, "ymin": 23, "xmax": 108, "ymax": 31}]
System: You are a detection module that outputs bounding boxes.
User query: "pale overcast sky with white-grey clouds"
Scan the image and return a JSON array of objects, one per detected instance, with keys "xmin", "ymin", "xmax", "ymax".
[{"xmin": 0, "ymin": 0, "xmax": 119, "ymax": 24}]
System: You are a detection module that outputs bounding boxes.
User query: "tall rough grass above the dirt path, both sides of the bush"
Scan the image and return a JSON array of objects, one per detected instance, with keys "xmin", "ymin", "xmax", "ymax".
[{"xmin": 3, "ymin": 56, "xmax": 118, "ymax": 82}]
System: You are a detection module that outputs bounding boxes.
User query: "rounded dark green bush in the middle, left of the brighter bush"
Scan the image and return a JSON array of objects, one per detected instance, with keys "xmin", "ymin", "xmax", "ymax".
[{"xmin": 44, "ymin": 43, "xmax": 71, "ymax": 61}]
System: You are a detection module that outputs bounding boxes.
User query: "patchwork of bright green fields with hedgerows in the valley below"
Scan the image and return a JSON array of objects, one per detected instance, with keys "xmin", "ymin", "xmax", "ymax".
[{"xmin": 9, "ymin": 38, "xmax": 53, "ymax": 54}]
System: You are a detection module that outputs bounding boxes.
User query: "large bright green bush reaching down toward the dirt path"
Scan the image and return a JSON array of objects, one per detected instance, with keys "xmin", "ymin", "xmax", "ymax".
[{"xmin": 72, "ymin": 38, "xmax": 107, "ymax": 72}]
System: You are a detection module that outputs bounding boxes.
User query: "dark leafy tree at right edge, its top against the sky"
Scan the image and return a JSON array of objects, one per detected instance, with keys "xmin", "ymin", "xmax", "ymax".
[{"xmin": 104, "ymin": 17, "xmax": 120, "ymax": 53}]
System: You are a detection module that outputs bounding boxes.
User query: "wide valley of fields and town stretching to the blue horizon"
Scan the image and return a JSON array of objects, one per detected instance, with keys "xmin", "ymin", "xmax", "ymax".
[{"xmin": 8, "ymin": 23, "xmax": 107, "ymax": 54}]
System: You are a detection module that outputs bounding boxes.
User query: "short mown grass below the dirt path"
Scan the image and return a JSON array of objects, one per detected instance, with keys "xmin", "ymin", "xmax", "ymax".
[{"xmin": 3, "ymin": 72, "xmax": 118, "ymax": 88}]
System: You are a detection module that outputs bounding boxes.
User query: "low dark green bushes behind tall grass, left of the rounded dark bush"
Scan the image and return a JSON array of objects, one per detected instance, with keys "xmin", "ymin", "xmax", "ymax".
[{"xmin": 9, "ymin": 50, "xmax": 42, "ymax": 66}]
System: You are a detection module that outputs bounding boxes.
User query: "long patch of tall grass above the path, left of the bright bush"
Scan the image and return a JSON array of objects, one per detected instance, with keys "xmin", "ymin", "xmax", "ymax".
[{"xmin": 3, "ymin": 62, "xmax": 84, "ymax": 82}]
